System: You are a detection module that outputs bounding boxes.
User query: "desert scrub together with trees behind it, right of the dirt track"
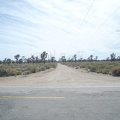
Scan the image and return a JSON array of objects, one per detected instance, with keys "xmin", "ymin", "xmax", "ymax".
[{"xmin": 60, "ymin": 51, "xmax": 120, "ymax": 76}]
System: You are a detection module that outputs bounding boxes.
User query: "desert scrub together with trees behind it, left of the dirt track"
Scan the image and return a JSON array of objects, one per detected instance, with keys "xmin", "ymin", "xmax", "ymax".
[{"xmin": 0, "ymin": 51, "xmax": 57, "ymax": 77}]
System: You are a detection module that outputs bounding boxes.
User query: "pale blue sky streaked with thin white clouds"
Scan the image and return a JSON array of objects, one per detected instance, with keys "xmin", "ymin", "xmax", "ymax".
[{"xmin": 0, "ymin": 0, "xmax": 120, "ymax": 60}]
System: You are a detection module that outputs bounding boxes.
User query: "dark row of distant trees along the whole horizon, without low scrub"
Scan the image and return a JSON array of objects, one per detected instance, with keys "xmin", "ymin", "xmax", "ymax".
[{"xmin": 0, "ymin": 51, "xmax": 120, "ymax": 64}]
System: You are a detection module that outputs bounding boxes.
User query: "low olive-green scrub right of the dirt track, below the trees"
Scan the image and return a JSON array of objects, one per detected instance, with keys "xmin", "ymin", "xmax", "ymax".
[{"xmin": 62, "ymin": 61, "xmax": 120, "ymax": 76}]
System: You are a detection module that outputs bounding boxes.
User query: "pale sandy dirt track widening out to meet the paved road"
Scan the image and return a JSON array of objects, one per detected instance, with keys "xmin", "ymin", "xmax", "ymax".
[{"xmin": 0, "ymin": 64, "xmax": 120, "ymax": 88}]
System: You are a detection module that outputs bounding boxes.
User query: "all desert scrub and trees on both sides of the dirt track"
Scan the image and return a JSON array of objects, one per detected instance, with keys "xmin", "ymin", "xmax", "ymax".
[{"xmin": 0, "ymin": 51, "xmax": 120, "ymax": 77}]
